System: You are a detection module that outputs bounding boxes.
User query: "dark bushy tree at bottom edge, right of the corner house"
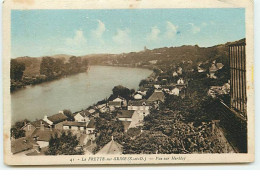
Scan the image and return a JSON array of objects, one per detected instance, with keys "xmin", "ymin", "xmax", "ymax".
[{"xmin": 45, "ymin": 131, "xmax": 84, "ymax": 155}]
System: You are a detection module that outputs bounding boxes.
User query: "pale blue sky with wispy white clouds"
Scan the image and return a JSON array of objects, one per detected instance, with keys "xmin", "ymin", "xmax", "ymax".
[{"xmin": 11, "ymin": 8, "xmax": 245, "ymax": 58}]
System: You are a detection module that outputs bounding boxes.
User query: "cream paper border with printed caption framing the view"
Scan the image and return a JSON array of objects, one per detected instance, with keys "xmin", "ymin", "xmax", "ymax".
[{"xmin": 2, "ymin": 0, "xmax": 255, "ymax": 165}]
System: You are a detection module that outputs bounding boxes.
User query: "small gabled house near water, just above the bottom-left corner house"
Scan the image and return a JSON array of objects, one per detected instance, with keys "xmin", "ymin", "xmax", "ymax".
[{"xmin": 22, "ymin": 120, "xmax": 50, "ymax": 137}]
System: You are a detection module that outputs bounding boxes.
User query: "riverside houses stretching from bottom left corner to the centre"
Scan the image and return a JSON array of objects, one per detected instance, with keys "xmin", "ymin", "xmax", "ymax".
[{"xmin": 11, "ymin": 82, "xmax": 170, "ymax": 155}]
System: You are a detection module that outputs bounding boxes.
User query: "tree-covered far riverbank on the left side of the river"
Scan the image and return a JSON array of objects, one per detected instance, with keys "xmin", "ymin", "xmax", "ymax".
[{"xmin": 10, "ymin": 56, "xmax": 89, "ymax": 93}]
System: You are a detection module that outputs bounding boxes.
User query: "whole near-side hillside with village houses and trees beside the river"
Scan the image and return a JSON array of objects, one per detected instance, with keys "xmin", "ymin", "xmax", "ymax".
[{"xmin": 11, "ymin": 39, "xmax": 244, "ymax": 156}]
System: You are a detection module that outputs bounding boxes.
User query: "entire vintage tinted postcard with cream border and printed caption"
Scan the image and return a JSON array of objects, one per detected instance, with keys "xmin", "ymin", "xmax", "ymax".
[{"xmin": 2, "ymin": 0, "xmax": 255, "ymax": 165}]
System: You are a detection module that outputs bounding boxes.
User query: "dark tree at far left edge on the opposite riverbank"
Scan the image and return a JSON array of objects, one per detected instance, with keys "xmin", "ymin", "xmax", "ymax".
[{"xmin": 10, "ymin": 59, "xmax": 25, "ymax": 80}]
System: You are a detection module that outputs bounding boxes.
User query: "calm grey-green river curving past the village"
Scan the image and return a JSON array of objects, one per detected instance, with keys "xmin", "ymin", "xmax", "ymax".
[{"xmin": 11, "ymin": 66, "xmax": 152, "ymax": 122}]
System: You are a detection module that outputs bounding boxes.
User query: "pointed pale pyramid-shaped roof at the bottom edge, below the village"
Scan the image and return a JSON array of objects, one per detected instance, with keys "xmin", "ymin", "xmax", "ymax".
[{"xmin": 96, "ymin": 137, "xmax": 123, "ymax": 155}]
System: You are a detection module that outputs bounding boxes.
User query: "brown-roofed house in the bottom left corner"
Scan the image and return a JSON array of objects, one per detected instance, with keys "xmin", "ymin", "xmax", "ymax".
[{"xmin": 11, "ymin": 137, "xmax": 38, "ymax": 155}]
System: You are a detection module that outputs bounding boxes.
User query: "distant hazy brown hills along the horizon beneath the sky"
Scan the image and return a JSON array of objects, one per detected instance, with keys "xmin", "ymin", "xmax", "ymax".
[{"xmin": 11, "ymin": 39, "xmax": 245, "ymax": 76}]
